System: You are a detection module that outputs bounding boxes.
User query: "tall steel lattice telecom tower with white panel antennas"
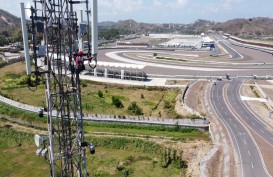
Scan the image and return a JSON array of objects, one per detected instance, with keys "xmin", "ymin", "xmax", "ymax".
[{"xmin": 21, "ymin": 0, "xmax": 98, "ymax": 177}]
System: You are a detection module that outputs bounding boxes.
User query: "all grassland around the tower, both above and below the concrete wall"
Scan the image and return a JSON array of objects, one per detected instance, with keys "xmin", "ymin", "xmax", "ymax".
[{"xmin": 0, "ymin": 63, "xmax": 209, "ymax": 177}]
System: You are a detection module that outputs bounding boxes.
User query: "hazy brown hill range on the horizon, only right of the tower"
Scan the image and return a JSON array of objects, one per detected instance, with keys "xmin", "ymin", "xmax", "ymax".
[{"xmin": 100, "ymin": 17, "xmax": 273, "ymax": 36}]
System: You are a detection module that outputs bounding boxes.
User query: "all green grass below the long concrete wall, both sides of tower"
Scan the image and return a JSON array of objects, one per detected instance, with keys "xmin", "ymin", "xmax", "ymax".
[{"xmin": 0, "ymin": 92, "xmax": 209, "ymax": 177}]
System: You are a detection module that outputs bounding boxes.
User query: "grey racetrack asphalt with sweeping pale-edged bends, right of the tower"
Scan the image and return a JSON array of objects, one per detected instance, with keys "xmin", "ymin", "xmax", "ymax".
[{"xmin": 98, "ymin": 37, "xmax": 273, "ymax": 76}]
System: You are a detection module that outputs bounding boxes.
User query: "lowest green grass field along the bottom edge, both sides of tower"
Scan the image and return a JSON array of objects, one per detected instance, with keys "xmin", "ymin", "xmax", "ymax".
[{"xmin": 0, "ymin": 126, "xmax": 186, "ymax": 177}]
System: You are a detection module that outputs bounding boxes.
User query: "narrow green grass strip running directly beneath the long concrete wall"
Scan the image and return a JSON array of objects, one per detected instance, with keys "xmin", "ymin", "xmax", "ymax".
[{"xmin": 0, "ymin": 102, "xmax": 209, "ymax": 141}]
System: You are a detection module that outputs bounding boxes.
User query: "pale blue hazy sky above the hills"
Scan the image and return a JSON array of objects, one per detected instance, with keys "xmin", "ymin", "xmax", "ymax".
[{"xmin": 3, "ymin": 0, "xmax": 273, "ymax": 23}]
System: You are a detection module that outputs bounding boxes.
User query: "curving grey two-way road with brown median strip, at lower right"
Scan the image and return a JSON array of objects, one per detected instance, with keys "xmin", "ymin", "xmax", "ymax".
[{"xmin": 210, "ymin": 81, "xmax": 270, "ymax": 177}]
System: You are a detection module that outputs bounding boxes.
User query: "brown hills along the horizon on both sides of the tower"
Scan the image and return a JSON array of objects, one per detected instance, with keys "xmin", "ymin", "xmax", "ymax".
[{"xmin": 0, "ymin": 9, "xmax": 273, "ymax": 46}]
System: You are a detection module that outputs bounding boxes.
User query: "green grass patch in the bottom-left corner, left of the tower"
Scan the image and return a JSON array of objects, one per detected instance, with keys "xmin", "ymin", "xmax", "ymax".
[{"xmin": 0, "ymin": 126, "xmax": 49, "ymax": 177}]
